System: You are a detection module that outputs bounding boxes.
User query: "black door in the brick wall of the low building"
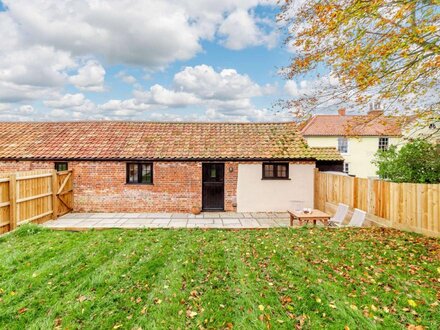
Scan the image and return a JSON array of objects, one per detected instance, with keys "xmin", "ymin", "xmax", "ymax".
[{"xmin": 202, "ymin": 163, "xmax": 225, "ymax": 211}]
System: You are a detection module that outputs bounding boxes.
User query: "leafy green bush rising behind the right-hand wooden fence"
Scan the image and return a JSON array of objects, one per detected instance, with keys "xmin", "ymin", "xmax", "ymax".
[{"xmin": 373, "ymin": 139, "xmax": 440, "ymax": 183}]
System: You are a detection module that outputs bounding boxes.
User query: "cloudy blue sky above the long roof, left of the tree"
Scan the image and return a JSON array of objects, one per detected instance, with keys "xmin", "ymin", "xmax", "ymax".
[{"xmin": 0, "ymin": 0, "xmax": 330, "ymax": 122}]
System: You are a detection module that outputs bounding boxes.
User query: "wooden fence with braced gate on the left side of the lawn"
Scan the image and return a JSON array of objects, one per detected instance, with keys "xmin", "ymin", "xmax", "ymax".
[{"xmin": 0, "ymin": 170, "xmax": 73, "ymax": 234}]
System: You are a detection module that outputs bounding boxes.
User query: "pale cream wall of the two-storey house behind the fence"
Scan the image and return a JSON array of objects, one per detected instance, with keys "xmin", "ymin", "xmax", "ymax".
[{"xmin": 305, "ymin": 136, "xmax": 401, "ymax": 178}]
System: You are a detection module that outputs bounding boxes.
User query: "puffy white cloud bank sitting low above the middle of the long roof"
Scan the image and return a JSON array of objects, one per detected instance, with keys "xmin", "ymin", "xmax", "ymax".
[{"xmin": 99, "ymin": 65, "xmax": 291, "ymax": 122}]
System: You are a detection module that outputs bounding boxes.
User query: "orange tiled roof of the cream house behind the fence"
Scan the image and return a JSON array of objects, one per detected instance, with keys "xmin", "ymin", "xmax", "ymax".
[{"xmin": 301, "ymin": 114, "xmax": 409, "ymax": 136}]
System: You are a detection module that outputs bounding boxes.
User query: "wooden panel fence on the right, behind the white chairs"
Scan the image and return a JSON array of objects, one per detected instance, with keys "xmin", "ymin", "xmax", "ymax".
[{"xmin": 315, "ymin": 171, "xmax": 440, "ymax": 237}]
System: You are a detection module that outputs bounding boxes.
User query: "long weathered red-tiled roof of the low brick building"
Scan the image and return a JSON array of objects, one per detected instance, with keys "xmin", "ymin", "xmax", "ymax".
[{"xmin": 0, "ymin": 121, "xmax": 342, "ymax": 160}]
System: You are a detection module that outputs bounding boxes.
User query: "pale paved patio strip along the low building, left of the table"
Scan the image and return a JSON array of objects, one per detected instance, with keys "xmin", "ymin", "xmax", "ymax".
[{"xmin": 42, "ymin": 212, "xmax": 296, "ymax": 230}]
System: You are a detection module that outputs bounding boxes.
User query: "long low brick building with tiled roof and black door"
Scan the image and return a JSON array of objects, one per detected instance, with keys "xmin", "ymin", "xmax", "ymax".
[{"xmin": 0, "ymin": 122, "xmax": 343, "ymax": 212}]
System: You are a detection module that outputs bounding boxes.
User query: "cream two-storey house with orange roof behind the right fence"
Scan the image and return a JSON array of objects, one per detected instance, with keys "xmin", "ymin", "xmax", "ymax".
[{"xmin": 301, "ymin": 109, "xmax": 411, "ymax": 178}]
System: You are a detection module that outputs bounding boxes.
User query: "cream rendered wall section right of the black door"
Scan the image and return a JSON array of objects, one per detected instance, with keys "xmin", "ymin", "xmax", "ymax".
[{"xmin": 237, "ymin": 163, "xmax": 315, "ymax": 212}]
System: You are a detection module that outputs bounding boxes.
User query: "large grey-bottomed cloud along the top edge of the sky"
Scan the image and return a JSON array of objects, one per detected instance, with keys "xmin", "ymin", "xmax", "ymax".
[{"xmin": 4, "ymin": 0, "xmax": 276, "ymax": 68}]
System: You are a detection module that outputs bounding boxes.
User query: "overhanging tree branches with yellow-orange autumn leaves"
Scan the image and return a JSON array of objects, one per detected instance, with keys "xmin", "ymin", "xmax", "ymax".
[{"xmin": 278, "ymin": 0, "xmax": 440, "ymax": 121}]
